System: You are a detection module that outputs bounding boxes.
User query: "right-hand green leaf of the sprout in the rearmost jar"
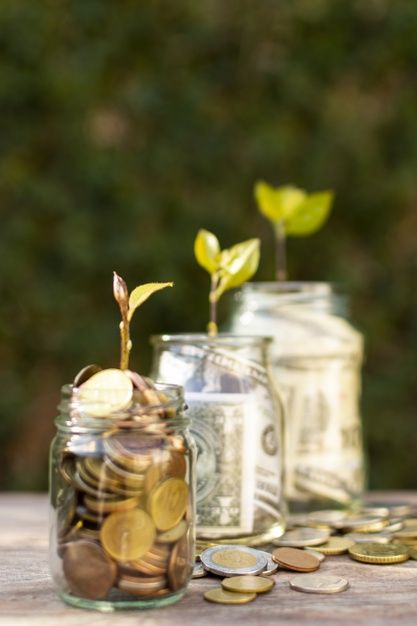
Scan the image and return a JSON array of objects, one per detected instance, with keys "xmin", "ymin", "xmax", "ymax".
[{"xmin": 285, "ymin": 191, "xmax": 334, "ymax": 237}]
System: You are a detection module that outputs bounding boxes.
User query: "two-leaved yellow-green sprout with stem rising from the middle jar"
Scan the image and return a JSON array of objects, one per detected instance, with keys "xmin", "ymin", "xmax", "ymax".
[{"xmin": 194, "ymin": 229, "xmax": 260, "ymax": 336}]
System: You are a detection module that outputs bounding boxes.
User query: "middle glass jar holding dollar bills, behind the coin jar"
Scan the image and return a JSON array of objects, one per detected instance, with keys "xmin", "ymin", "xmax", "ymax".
[{"xmin": 152, "ymin": 335, "xmax": 285, "ymax": 545}]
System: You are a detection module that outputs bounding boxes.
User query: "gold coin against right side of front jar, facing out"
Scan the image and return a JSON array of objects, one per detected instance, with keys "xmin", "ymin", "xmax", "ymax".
[{"xmin": 147, "ymin": 478, "xmax": 188, "ymax": 531}]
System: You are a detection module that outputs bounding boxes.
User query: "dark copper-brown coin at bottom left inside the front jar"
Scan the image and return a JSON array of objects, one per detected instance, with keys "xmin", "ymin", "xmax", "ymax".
[{"xmin": 63, "ymin": 541, "xmax": 117, "ymax": 600}]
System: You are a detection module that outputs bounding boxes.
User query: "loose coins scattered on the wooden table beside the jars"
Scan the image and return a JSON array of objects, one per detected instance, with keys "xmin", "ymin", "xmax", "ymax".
[{"xmin": 193, "ymin": 503, "xmax": 417, "ymax": 604}]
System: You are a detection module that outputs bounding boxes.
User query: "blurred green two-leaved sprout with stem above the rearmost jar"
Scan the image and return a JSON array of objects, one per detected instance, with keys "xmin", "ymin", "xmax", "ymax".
[{"xmin": 254, "ymin": 181, "xmax": 334, "ymax": 281}]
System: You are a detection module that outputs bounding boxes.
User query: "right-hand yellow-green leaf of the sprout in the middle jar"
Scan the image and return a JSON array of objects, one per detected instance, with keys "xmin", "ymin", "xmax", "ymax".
[{"xmin": 215, "ymin": 239, "xmax": 260, "ymax": 300}]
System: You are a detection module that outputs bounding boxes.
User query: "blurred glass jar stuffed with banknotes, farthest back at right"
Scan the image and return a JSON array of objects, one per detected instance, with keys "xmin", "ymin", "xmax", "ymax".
[{"xmin": 231, "ymin": 282, "xmax": 365, "ymax": 512}]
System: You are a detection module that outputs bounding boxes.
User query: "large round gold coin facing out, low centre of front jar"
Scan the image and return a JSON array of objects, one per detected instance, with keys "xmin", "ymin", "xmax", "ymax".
[{"xmin": 100, "ymin": 509, "xmax": 155, "ymax": 561}]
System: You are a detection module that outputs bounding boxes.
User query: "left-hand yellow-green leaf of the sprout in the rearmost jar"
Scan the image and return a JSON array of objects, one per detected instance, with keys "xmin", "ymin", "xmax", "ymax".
[{"xmin": 255, "ymin": 181, "xmax": 307, "ymax": 223}]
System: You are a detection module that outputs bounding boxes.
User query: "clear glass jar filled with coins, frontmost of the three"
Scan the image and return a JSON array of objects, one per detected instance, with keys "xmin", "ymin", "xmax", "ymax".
[{"xmin": 50, "ymin": 385, "xmax": 196, "ymax": 611}]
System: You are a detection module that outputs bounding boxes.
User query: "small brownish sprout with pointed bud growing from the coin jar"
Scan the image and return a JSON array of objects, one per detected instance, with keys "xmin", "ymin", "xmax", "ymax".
[{"xmin": 113, "ymin": 272, "xmax": 174, "ymax": 370}]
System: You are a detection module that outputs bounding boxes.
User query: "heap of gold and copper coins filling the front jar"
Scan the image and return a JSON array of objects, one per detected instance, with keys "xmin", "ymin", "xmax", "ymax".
[{"xmin": 55, "ymin": 370, "xmax": 193, "ymax": 600}]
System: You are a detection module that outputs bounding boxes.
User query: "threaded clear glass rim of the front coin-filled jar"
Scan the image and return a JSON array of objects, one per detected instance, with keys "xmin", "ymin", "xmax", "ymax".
[{"xmin": 55, "ymin": 382, "xmax": 189, "ymax": 430}]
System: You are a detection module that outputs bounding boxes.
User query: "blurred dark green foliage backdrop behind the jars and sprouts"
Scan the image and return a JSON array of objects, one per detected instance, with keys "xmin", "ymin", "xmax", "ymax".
[{"xmin": 0, "ymin": 0, "xmax": 417, "ymax": 489}]
